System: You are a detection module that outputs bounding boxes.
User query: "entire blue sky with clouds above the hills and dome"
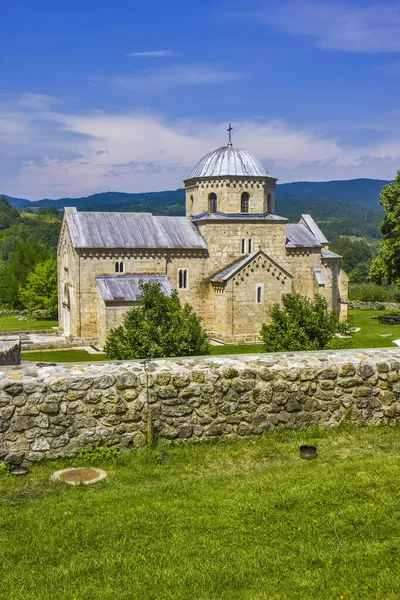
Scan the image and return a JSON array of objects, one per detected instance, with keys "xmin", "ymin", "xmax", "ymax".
[{"xmin": 0, "ymin": 0, "xmax": 400, "ymax": 199}]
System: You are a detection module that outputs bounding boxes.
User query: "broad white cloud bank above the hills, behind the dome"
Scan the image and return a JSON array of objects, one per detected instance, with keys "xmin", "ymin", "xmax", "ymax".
[{"xmin": 0, "ymin": 92, "xmax": 400, "ymax": 199}]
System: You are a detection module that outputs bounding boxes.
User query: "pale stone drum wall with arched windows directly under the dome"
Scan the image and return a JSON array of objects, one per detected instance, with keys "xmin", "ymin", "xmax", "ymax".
[{"xmin": 186, "ymin": 178, "xmax": 276, "ymax": 216}]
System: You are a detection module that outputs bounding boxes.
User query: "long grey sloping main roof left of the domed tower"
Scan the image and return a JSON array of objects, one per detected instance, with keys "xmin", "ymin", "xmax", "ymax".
[{"xmin": 65, "ymin": 207, "xmax": 207, "ymax": 249}]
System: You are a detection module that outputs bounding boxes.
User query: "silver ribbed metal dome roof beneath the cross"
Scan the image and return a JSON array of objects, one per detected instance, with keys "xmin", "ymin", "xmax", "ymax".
[{"xmin": 188, "ymin": 144, "xmax": 269, "ymax": 179}]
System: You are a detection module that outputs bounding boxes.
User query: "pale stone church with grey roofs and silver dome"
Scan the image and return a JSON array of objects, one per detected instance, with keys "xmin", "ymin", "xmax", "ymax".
[{"xmin": 58, "ymin": 133, "xmax": 348, "ymax": 346}]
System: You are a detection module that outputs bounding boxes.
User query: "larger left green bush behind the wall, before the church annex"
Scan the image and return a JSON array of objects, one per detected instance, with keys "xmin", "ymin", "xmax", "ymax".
[{"xmin": 105, "ymin": 282, "xmax": 210, "ymax": 360}]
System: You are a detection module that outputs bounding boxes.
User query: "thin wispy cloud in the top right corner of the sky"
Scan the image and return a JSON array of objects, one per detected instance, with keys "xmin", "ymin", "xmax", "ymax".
[{"xmin": 231, "ymin": 0, "xmax": 400, "ymax": 53}]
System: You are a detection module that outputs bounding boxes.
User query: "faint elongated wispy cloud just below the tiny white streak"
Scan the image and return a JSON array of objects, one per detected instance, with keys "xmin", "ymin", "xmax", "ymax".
[{"xmin": 112, "ymin": 63, "xmax": 245, "ymax": 91}]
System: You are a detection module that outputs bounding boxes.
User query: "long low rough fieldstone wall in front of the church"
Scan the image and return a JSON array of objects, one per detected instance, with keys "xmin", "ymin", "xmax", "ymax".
[{"xmin": 0, "ymin": 348, "xmax": 400, "ymax": 462}]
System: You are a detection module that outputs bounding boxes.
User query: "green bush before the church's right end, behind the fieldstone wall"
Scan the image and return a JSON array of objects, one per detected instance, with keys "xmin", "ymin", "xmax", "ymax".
[{"xmin": 261, "ymin": 294, "xmax": 349, "ymax": 352}]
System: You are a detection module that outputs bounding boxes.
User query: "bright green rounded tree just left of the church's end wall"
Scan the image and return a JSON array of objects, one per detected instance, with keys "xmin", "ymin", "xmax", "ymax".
[{"xmin": 19, "ymin": 258, "xmax": 58, "ymax": 315}]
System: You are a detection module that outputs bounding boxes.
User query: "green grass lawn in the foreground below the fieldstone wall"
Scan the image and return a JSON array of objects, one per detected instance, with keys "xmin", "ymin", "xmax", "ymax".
[{"xmin": 0, "ymin": 427, "xmax": 400, "ymax": 600}]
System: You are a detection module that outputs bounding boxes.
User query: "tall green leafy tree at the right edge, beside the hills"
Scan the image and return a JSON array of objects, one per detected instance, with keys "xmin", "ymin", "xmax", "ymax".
[{"xmin": 369, "ymin": 169, "xmax": 400, "ymax": 287}]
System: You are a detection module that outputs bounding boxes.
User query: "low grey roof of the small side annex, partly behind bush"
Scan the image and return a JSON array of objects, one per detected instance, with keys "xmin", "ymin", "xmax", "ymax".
[{"xmin": 96, "ymin": 275, "xmax": 173, "ymax": 302}]
